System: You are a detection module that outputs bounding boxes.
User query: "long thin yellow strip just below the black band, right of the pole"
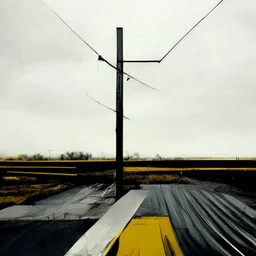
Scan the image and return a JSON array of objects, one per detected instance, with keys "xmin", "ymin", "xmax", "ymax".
[{"xmin": 124, "ymin": 167, "xmax": 256, "ymax": 172}]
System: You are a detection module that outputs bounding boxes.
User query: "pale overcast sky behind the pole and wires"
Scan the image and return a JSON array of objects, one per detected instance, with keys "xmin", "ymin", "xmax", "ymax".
[{"xmin": 0, "ymin": 0, "xmax": 256, "ymax": 157}]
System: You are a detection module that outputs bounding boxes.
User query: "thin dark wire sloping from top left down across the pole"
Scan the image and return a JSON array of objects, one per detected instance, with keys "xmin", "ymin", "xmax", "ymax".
[{"xmin": 39, "ymin": 0, "xmax": 158, "ymax": 91}]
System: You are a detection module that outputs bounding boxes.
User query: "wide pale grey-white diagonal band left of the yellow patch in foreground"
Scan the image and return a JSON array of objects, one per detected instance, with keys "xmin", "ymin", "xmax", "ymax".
[{"xmin": 65, "ymin": 190, "xmax": 148, "ymax": 256}]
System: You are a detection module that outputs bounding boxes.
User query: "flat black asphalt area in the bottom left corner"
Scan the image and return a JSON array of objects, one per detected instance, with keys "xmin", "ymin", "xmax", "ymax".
[{"xmin": 0, "ymin": 220, "xmax": 96, "ymax": 256}]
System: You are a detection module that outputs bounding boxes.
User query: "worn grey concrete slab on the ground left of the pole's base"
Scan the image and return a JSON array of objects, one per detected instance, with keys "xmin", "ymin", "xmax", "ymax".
[{"xmin": 0, "ymin": 184, "xmax": 115, "ymax": 220}]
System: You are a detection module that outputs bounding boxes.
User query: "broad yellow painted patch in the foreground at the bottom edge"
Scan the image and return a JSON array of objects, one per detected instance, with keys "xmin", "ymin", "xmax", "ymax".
[{"xmin": 109, "ymin": 217, "xmax": 183, "ymax": 256}]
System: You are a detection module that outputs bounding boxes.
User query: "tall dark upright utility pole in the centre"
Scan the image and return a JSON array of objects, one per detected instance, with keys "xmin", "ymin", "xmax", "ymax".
[{"xmin": 116, "ymin": 28, "xmax": 123, "ymax": 199}]
